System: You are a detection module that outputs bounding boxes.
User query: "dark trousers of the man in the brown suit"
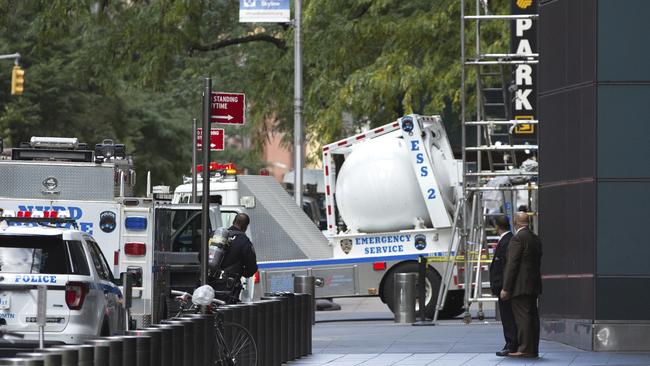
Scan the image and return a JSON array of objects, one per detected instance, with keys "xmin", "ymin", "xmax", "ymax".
[{"xmin": 510, "ymin": 295, "xmax": 539, "ymax": 355}]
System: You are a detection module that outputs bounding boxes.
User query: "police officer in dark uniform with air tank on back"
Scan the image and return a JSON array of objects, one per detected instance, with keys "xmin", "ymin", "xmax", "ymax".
[{"xmin": 208, "ymin": 213, "xmax": 257, "ymax": 303}]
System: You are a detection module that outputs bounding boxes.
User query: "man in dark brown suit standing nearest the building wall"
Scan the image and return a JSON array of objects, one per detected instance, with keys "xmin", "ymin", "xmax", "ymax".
[{"xmin": 500, "ymin": 212, "xmax": 542, "ymax": 357}]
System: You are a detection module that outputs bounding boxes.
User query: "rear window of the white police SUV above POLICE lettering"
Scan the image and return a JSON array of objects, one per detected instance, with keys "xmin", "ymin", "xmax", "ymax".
[{"xmin": 0, "ymin": 235, "xmax": 70, "ymax": 274}]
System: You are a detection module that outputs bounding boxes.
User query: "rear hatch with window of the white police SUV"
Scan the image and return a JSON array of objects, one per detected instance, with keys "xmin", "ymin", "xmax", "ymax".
[{"xmin": 0, "ymin": 235, "xmax": 82, "ymax": 332}]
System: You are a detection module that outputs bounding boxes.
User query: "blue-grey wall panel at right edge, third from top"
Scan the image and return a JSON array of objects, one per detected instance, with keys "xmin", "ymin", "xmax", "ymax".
[{"xmin": 596, "ymin": 182, "xmax": 650, "ymax": 274}]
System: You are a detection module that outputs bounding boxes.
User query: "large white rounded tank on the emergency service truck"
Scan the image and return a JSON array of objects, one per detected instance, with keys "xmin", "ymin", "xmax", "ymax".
[{"xmin": 335, "ymin": 120, "xmax": 456, "ymax": 233}]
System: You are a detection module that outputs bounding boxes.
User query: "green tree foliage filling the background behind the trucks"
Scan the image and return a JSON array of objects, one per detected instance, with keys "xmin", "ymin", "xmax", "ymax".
[{"xmin": 0, "ymin": 0, "xmax": 509, "ymax": 189}]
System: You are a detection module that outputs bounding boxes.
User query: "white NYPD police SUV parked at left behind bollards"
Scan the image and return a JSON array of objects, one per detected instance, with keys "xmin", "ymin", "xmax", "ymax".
[{"xmin": 0, "ymin": 213, "xmax": 126, "ymax": 343}]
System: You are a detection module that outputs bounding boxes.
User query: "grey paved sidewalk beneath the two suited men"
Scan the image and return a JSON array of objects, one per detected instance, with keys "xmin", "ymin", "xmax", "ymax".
[{"xmin": 288, "ymin": 298, "xmax": 650, "ymax": 366}]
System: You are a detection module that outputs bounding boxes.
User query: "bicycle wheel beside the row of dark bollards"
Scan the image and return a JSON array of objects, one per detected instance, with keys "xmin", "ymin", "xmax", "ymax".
[{"xmin": 216, "ymin": 323, "xmax": 257, "ymax": 366}]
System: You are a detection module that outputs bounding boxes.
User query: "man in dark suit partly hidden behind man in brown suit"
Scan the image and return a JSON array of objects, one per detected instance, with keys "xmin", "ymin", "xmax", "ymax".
[{"xmin": 490, "ymin": 216, "xmax": 518, "ymax": 356}]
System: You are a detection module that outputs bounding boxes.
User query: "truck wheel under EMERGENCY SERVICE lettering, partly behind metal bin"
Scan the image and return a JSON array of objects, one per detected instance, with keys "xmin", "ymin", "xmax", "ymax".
[{"xmin": 382, "ymin": 262, "xmax": 442, "ymax": 318}]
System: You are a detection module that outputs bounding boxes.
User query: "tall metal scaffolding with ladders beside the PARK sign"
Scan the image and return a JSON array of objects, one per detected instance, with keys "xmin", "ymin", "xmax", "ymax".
[{"xmin": 433, "ymin": 0, "xmax": 539, "ymax": 323}]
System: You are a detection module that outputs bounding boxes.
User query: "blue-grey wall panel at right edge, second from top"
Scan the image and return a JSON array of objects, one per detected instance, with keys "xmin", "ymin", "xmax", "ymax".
[{"xmin": 598, "ymin": 84, "xmax": 650, "ymax": 178}]
